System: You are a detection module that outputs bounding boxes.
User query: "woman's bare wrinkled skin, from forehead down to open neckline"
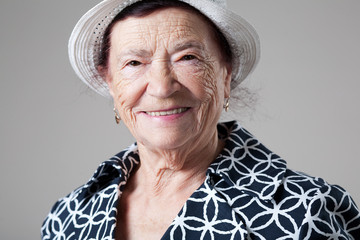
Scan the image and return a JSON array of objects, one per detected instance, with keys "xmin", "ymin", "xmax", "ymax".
[{"xmin": 104, "ymin": 8, "xmax": 231, "ymax": 239}]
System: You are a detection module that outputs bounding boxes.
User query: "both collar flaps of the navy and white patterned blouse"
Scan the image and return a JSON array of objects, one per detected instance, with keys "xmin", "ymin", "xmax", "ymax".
[{"xmin": 90, "ymin": 121, "xmax": 286, "ymax": 200}]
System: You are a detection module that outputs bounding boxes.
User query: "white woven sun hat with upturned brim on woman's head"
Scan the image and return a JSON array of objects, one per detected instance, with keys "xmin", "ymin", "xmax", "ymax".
[{"xmin": 68, "ymin": 0, "xmax": 260, "ymax": 97}]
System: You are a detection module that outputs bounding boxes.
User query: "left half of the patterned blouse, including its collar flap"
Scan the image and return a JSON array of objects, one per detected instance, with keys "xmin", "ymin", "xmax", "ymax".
[{"xmin": 41, "ymin": 145, "xmax": 138, "ymax": 239}]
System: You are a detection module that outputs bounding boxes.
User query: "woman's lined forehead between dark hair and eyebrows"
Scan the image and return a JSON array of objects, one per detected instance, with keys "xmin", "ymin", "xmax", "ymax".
[{"xmin": 111, "ymin": 8, "xmax": 211, "ymax": 46}]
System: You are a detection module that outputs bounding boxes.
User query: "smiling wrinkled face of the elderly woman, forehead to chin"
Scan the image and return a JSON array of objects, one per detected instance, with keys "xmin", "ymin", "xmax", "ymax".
[{"xmin": 106, "ymin": 8, "xmax": 231, "ymax": 150}]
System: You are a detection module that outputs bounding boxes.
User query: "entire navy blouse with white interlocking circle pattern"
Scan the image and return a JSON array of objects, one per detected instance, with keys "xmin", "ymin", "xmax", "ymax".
[{"xmin": 41, "ymin": 122, "xmax": 360, "ymax": 240}]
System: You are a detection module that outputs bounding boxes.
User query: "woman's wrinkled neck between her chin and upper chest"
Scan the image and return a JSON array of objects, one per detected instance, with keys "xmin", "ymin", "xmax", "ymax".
[{"xmin": 131, "ymin": 129, "xmax": 223, "ymax": 197}]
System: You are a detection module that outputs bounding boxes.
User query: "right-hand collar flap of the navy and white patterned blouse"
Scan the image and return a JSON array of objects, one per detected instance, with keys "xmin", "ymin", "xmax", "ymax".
[{"xmin": 208, "ymin": 121, "xmax": 287, "ymax": 200}]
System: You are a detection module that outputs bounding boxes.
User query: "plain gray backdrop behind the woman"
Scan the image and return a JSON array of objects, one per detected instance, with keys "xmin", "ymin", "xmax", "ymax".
[{"xmin": 0, "ymin": 0, "xmax": 360, "ymax": 239}]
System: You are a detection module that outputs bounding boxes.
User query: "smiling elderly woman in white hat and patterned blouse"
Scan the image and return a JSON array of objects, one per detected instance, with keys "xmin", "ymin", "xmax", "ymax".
[{"xmin": 42, "ymin": 0, "xmax": 360, "ymax": 239}]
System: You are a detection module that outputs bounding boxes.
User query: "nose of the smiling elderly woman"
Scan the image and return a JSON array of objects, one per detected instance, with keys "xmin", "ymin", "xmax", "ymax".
[{"xmin": 146, "ymin": 61, "xmax": 181, "ymax": 98}]
